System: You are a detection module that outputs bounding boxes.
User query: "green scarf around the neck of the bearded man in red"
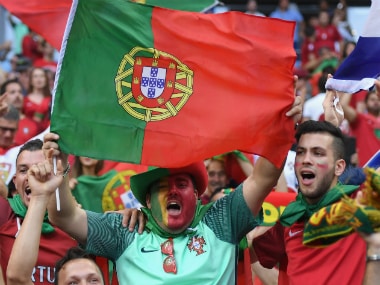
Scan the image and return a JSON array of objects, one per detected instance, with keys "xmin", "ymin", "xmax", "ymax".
[{"xmin": 280, "ymin": 183, "xmax": 359, "ymax": 227}]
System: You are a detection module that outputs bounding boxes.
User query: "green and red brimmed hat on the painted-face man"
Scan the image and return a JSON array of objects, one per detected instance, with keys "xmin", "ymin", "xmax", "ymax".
[{"xmin": 130, "ymin": 161, "xmax": 208, "ymax": 207}]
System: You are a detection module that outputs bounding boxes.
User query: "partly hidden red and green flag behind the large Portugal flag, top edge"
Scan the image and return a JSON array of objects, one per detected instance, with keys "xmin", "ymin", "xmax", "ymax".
[{"xmin": 0, "ymin": 0, "xmax": 218, "ymax": 50}]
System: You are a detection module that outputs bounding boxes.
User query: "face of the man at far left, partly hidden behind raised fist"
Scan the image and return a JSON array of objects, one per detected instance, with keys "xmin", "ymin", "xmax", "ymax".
[{"xmin": 13, "ymin": 150, "xmax": 45, "ymax": 207}]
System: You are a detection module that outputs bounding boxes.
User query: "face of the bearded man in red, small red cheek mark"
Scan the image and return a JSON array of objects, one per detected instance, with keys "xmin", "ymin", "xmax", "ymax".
[{"xmin": 294, "ymin": 133, "xmax": 345, "ymax": 204}]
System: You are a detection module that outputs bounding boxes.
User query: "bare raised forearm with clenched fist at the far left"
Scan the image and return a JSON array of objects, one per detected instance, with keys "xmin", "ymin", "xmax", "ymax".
[{"xmin": 7, "ymin": 150, "xmax": 62, "ymax": 285}]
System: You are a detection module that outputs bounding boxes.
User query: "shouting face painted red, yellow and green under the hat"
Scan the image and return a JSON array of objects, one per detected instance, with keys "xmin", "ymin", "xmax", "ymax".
[{"xmin": 147, "ymin": 174, "xmax": 198, "ymax": 234}]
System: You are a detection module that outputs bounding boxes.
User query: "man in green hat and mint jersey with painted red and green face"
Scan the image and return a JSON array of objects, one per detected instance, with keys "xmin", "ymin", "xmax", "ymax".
[{"xmin": 44, "ymin": 98, "xmax": 301, "ymax": 284}]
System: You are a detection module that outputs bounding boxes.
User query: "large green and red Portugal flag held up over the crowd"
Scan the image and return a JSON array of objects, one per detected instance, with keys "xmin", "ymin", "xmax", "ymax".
[{"xmin": 51, "ymin": 0, "xmax": 295, "ymax": 167}]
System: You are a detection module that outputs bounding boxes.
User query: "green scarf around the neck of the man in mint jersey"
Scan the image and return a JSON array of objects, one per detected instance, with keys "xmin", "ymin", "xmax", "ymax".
[{"xmin": 141, "ymin": 201, "xmax": 213, "ymax": 238}]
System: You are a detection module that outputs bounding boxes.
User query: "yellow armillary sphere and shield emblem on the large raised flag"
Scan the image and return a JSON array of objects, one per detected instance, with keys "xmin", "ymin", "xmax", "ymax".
[{"xmin": 115, "ymin": 47, "xmax": 193, "ymax": 122}]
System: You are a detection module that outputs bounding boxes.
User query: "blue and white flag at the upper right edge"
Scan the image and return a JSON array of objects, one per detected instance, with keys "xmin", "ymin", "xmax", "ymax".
[{"xmin": 326, "ymin": 0, "xmax": 380, "ymax": 94}]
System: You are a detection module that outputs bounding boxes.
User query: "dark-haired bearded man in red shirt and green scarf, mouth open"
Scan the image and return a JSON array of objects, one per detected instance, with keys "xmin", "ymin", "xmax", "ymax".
[{"xmin": 252, "ymin": 120, "xmax": 366, "ymax": 285}]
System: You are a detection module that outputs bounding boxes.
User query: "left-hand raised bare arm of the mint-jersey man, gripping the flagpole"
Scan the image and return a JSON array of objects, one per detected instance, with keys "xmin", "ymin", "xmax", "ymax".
[{"xmin": 43, "ymin": 133, "xmax": 87, "ymax": 244}]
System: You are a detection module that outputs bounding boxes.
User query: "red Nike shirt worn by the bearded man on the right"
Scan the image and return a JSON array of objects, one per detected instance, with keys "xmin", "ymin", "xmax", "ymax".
[{"xmin": 253, "ymin": 223, "xmax": 366, "ymax": 285}]
